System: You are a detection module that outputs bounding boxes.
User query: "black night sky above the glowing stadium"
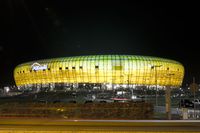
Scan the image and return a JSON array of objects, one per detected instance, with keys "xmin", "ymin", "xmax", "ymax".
[{"xmin": 0, "ymin": 0, "xmax": 200, "ymax": 86}]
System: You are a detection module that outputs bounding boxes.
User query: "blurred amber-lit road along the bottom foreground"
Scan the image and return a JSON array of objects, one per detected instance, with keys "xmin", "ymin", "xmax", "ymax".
[{"xmin": 0, "ymin": 118, "xmax": 200, "ymax": 133}]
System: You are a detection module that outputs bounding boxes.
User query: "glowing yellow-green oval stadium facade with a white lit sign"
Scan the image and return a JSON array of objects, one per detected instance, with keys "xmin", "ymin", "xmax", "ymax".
[{"xmin": 14, "ymin": 55, "xmax": 184, "ymax": 90}]
